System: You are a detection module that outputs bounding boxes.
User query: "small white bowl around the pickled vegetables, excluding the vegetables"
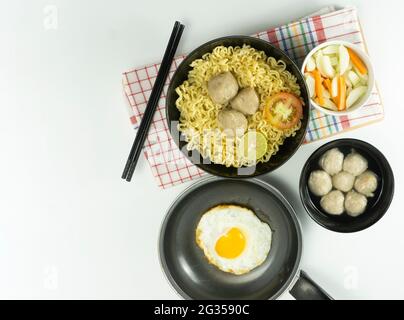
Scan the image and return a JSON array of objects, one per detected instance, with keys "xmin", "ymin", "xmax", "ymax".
[{"xmin": 301, "ymin": 40, "xmax": 375, "ymax": 116}]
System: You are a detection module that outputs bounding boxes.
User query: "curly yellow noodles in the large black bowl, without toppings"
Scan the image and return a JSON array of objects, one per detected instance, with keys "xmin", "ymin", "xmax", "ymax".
[{"xmin": 176, "ymin": 45, "xmax": 301, "ymax": 167}]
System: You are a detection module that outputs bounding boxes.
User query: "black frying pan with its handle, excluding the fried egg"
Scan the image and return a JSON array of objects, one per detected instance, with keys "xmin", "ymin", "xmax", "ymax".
[{"xmin": 159, "ymin": 178, "xmax": 329, "ymax": 299}]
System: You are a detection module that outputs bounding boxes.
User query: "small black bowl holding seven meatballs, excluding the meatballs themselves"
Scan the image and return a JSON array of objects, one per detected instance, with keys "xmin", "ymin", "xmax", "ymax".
[{"xmin": 299, "ymin": 139, "xmax": 394, "ymax": 233}]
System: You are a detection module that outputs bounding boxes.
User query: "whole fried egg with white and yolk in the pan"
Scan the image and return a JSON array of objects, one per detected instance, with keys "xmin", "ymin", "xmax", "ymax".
[{"xmin": 196, "ymin": 205, "xmax": 272, "ymax": 275}]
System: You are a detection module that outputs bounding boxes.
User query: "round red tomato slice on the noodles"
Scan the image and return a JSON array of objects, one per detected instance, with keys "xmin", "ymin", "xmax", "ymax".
[{"xmin": 263, "ymin": 92, "xmax": 303, "ymax": 130}]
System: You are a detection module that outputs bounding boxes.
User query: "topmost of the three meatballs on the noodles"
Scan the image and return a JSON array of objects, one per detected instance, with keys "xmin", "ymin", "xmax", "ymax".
[{"xmin": 208, "ymin": 72, "xmax": 238, "ymax": 104}]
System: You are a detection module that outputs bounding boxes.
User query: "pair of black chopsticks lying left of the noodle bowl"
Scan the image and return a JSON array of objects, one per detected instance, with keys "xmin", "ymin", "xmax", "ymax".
[{"xmin": 122, "ymin": 21, "xmax": 184, "ymax": 181}]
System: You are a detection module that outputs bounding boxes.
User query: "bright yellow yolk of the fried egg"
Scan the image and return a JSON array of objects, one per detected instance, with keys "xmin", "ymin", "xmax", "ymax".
[{"xmin": 215, "ymin": 228, "xmax": 246, "ymax": 259}]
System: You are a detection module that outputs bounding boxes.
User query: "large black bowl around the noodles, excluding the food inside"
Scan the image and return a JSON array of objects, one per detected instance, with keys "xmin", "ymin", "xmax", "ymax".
[{"xmin": 166, "ymin": 36, "xmax": 310, "ymax": 178}]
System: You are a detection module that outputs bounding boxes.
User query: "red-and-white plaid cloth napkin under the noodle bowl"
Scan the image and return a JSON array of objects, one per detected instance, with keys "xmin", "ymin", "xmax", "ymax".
[{"xmin": 123, "ymin": 7, "xmax": 384, "ymax": 188}]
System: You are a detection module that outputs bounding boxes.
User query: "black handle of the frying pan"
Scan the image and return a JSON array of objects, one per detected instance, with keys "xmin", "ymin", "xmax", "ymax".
[{"xmin": 289, "ymin": 270, "xmax": 333, "ymax": 300}]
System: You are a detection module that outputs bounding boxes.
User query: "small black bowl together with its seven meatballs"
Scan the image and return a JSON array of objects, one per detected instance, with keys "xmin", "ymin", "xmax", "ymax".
[{"xmin": 299, "ymin": 139, "xmax": 394, "ymax": 233}]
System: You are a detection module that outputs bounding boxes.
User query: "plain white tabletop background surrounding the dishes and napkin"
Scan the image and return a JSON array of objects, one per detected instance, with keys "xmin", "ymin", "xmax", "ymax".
[{"xmin": 0, "ymin": 0, "xmax": 404, "ymax": 299}]
